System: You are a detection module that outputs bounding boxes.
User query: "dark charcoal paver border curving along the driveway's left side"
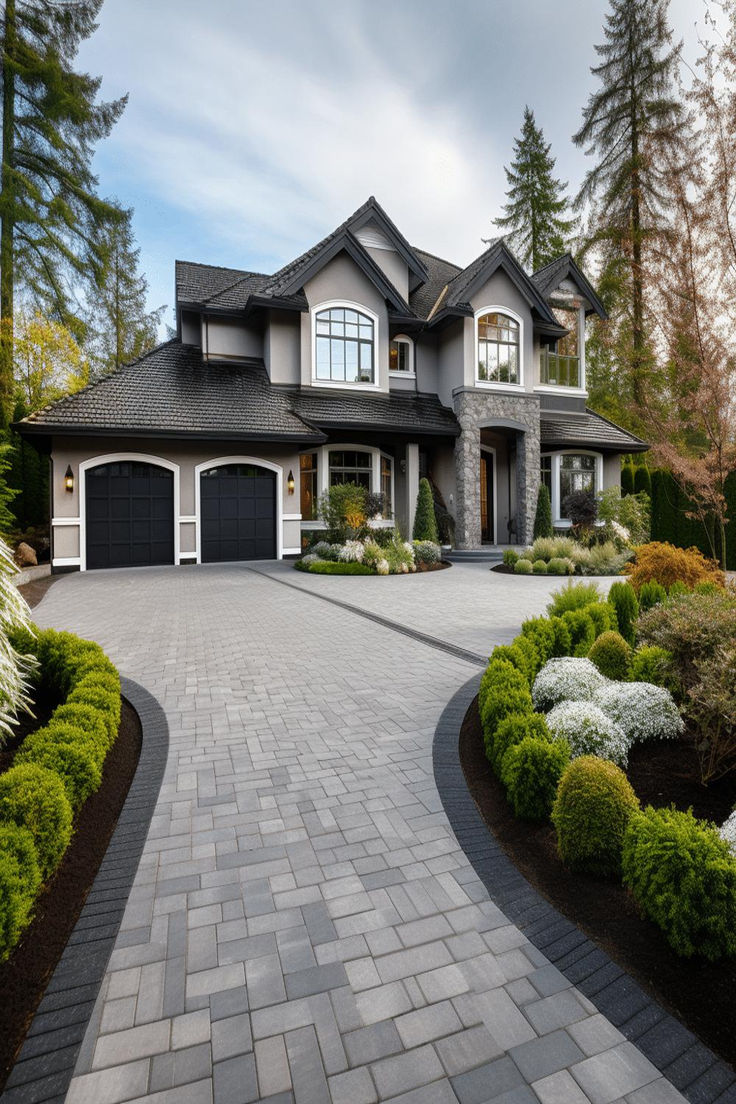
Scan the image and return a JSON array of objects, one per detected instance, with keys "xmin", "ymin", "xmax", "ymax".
[{"xmin": 1, "ymin": 678, "xmax": 169, "ymax": 1104}]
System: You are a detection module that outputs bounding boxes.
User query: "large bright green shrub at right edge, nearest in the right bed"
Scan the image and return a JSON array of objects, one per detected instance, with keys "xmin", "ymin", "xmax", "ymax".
[{"xmin": 621, "ymin": 806, "xmax": 736, "ymax": 962}]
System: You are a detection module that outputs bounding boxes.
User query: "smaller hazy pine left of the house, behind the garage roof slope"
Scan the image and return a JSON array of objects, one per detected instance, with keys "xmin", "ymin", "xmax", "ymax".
[{"xmin": 88, "ymin": 211, "xmax": 166, "ymax": 379}]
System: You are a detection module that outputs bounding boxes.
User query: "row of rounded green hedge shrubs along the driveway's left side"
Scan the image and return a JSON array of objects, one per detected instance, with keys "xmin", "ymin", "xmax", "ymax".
[{"xmin": 0, "ymin": 629, "xmax": 120, "ymax": 960}]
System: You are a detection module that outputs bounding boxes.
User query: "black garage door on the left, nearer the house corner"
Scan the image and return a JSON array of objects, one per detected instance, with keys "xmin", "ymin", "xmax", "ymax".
[{"xmin": 86, "ymin": 460, "xmax": 173, "ymax": 567}]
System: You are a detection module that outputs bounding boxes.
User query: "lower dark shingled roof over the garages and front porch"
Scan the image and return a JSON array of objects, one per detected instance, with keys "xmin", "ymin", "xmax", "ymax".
[{"xmin": 20, "ymin": 340, "xmax": 459, "ymax": 444}]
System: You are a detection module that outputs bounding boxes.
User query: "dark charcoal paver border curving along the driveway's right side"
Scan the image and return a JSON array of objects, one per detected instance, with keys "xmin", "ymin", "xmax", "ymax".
[{"xmin": 433, "ymin": 676, "xmax": 736, "ymax": 1104}]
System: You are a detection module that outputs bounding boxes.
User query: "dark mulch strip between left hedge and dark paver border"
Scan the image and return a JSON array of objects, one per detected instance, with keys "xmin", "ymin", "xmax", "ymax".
[{"xmin": 0, "ymin": 697, "xmax": 141, "ymax": 1092}]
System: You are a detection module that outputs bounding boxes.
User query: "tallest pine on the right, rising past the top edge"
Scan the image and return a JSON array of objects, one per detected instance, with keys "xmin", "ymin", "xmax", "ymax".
[{"xmin": 573, "ymin": 0, "xmax": 686, "ymax": 406}]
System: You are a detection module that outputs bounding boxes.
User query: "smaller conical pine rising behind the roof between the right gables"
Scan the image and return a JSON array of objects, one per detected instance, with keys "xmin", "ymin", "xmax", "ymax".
[{"xmin": 494, "ymin": 107, "xmax": 576, "ymax": 272}]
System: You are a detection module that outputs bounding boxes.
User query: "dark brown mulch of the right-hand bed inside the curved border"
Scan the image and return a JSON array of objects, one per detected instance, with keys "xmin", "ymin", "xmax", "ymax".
[{"xmin": 459, "ymin": 699, "xmax": 736, "ymax": 1065}]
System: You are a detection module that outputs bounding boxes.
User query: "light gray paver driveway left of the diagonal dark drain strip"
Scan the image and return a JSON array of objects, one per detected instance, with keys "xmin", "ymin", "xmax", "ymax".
[{"xmin": 28, "ymin": 565, "xmax": 681, "ymax": 1104}]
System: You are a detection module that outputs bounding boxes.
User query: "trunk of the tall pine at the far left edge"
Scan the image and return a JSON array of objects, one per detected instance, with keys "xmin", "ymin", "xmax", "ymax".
[{"xmin": 0, "ymin": 0, "xmax": 17, "ymax": 429}]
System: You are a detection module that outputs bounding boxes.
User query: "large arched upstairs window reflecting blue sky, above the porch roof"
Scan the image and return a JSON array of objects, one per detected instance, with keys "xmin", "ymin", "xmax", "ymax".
[{"xmin": 314, "ymin": 307, "xmax": 374, "ymax": 383}]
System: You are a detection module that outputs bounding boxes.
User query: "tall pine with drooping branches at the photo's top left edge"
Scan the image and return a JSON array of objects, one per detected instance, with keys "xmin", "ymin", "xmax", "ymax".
[{"xmin": 0, "ymin": 0, "xmax": 125, "ymax": 424}]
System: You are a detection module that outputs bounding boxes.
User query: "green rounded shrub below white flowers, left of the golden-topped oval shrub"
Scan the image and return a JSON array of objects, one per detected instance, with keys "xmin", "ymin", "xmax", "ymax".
[{"xmin": 501, "ymin": 736, "xmax": 570, "ymax": 820}]
